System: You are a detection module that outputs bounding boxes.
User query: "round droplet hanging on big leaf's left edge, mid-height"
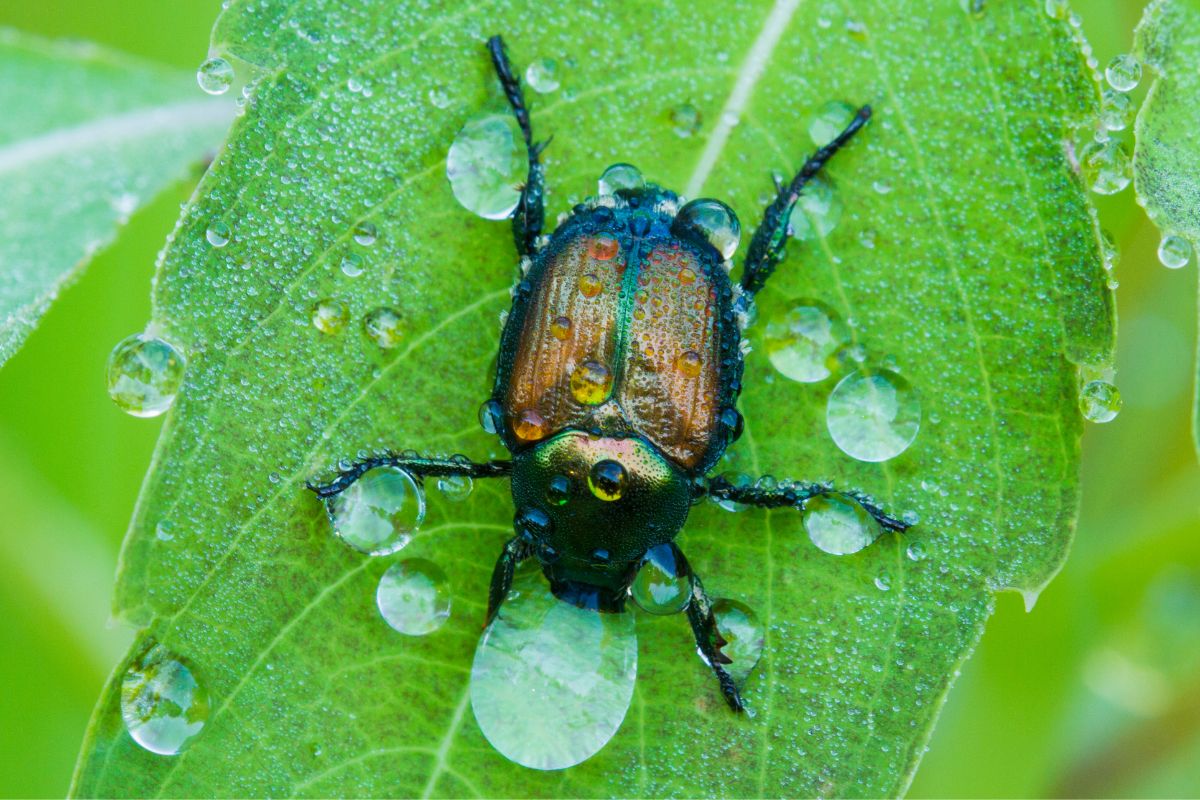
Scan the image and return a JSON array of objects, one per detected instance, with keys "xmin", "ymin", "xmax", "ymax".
[{"xmin": 108, "ymin": 333, "xmax": 185, "ymax": 416}]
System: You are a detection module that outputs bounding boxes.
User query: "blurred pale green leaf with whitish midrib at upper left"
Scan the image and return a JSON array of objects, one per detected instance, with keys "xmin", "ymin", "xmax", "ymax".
[{"xmin": 0, "ymin": 29, "xmax": 230, "ymax": 363}]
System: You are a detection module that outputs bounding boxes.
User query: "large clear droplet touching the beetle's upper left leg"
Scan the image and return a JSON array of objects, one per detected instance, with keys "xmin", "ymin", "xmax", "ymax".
[{"xmin": 446, "ymin": 114, "xmax": 526, "ymax": 219}]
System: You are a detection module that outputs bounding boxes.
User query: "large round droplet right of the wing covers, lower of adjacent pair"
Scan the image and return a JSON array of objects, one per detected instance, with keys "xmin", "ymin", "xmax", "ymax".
[{"xmin": 826, "ymin": 369, "xmax": 920, "ymax": 462}]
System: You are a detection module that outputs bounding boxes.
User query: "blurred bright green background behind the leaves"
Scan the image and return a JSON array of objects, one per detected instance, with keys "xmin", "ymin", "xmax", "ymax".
[{"xmin": 0, "ymin": 0, "xmax": 1185, "ymax": 798}]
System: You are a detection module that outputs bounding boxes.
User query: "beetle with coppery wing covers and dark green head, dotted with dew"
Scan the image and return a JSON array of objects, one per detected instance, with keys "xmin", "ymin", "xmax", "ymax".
[{"xmin": 312, "ymin": 36, "xmax": 907, "ymax": 711}]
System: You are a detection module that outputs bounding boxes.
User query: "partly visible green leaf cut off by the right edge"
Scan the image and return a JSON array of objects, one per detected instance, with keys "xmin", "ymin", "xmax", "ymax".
[{"xmin": 1133, "ymin": 0, "xmax": 1200, "ymax": 460}]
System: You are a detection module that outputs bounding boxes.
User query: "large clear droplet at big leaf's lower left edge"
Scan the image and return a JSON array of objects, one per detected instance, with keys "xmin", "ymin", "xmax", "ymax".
[{"xmin": 121, "ymin": 644, "xmax": 209, "ymax": 756}]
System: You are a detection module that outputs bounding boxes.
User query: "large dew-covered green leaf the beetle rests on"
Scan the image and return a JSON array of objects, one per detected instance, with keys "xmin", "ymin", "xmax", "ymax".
[{"xmin": 73, "ymin": 0, "xmax": 1114, "ymax": 796}]
